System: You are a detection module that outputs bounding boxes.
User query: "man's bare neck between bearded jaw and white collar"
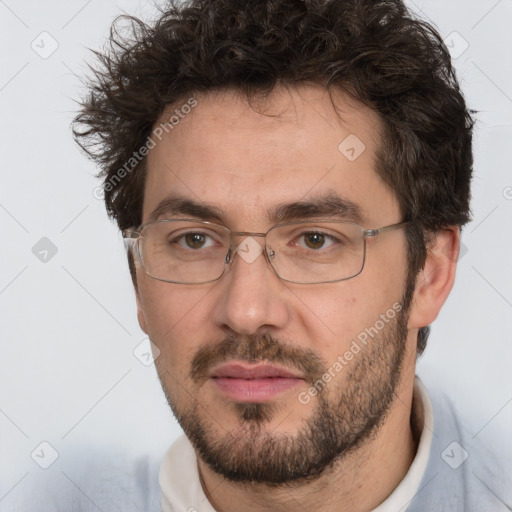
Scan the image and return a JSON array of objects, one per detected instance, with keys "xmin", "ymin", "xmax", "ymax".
[{"xmin": 198, "ymin": 365, "xmax": 418, "ymax": 512}]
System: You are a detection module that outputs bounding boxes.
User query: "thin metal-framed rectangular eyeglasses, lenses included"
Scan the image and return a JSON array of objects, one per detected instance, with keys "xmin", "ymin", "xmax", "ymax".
[{"xmin": 123, "ymin": 219, "xmax": 409, "ymax": 284}]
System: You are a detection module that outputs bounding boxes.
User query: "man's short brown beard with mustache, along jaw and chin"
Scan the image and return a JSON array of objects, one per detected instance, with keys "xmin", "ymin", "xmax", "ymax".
[{"xmin": 161, "ymin": 286, "xmax": 412, "ymax": 486}]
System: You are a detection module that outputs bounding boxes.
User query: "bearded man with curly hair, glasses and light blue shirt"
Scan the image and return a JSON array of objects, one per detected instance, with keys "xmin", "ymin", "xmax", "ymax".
[{"xmin": 75, "ymin": 0, "xmax": 512, "ymax": 512}]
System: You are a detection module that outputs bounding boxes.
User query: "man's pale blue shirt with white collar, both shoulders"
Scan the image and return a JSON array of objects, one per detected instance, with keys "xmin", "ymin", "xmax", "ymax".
[{"xmin": 10, "ymin": 380, "xmax": 512, "ymax": 512}]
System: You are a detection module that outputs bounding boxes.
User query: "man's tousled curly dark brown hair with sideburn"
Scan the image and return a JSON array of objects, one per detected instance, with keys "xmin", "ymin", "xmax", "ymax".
[{"xmin": 73, "ymin": 0, "xmax": 474, "ymax": 353}]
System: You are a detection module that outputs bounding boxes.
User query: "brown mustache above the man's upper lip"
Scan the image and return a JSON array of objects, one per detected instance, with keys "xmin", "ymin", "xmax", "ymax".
[{"xmin": 190, "ymin": 334, "xmax": 327, "ymax": 385}]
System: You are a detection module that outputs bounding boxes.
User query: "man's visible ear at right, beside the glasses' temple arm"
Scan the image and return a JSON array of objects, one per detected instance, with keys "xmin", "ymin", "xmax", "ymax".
[{"xmin": 409, "ymin": 226, "xmax": 460, "ymax": 329}]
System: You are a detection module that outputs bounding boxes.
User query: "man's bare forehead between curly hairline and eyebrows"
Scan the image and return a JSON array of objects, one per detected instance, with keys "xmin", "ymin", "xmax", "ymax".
[{"xmin": 143, "ymin": 86, "xmax": 398, "ymax": 229}]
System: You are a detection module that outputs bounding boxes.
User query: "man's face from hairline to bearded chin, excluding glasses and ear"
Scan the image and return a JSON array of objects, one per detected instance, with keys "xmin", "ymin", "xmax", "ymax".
[{"xmin": 137, "ymin": 86, "xmax": 414, "ymax": 483}]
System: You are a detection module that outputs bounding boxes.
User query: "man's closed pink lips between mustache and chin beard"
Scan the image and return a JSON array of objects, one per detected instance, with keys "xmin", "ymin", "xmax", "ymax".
[{"xmin": 210, "ymin": 362, "xmax": 305, "ymax": 403}]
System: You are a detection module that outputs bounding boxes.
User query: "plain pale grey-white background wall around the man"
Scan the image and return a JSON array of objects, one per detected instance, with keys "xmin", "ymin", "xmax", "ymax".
[{"xmin": 0, "ymin": 0, "xmax": 512, "ymax": 511}]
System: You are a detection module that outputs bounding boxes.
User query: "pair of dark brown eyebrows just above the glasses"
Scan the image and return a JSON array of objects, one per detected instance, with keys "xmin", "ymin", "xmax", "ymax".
[{"xmin": 148, "ymin": 191, "xmax": 364, "ymax": 224}]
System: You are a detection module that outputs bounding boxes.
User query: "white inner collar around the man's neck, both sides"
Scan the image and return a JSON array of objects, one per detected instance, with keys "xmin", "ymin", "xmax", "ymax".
[{"xmin": 159, "ymin": 377, "xmax": 434, "ymax": 512}]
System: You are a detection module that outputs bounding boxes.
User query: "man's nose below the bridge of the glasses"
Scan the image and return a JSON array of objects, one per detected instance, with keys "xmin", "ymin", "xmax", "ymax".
[{"xmin": 213, "ymin": 237, "xmax": 290, "ymax": 335}]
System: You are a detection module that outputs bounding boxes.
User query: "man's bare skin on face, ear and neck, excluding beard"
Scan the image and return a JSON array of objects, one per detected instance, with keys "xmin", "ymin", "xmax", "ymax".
[{"xmin": 136, "ymin": 85, "xmax": 459, "ymax": 512}]
